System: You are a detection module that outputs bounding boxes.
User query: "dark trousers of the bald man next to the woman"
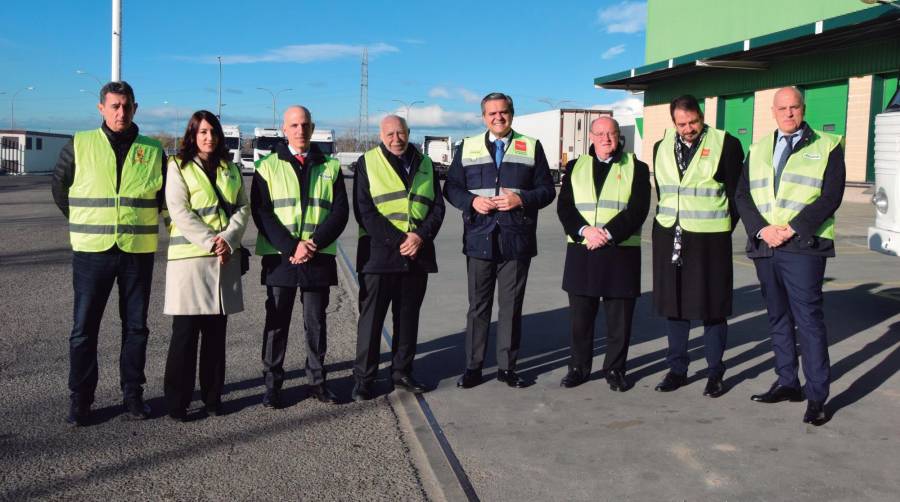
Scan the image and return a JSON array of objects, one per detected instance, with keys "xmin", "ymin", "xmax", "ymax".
[{"xmin": 262, "ymin": 286, "xmax": 330, "ymax": 390}]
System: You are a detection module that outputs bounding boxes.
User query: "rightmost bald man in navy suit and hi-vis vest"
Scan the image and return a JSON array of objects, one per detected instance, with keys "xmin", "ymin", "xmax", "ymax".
[{"xmin": 735, "ymin": 87, "xmax": 846, "ymax": 425}]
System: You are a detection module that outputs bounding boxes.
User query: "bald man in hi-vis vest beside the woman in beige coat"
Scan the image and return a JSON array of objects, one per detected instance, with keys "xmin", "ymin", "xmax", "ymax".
[{"xmin": 250, "ymin": 105, "xmax": 350, "ymax": 408}]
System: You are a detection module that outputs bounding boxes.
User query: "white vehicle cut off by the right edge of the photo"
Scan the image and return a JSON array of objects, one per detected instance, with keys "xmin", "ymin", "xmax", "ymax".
[{"xmin": 868, "ymin": 90, "xmax": 900, "ymax": 256}]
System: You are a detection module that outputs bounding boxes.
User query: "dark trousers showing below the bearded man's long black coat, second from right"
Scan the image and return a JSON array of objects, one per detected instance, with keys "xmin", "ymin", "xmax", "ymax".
[{"xmin": 666, "ymin": 318, "xmax": 728, "ymax": 378}]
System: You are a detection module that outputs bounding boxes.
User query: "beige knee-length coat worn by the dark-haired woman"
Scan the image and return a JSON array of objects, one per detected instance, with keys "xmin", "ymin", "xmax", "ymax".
[{"xmin": 163, "ymin": 157, "xmax": 250, "ymax": 315}]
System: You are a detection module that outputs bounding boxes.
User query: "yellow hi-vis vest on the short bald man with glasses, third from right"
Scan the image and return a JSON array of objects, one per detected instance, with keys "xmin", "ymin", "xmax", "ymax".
[{"xmin": 566, "ymin": 153, "xmax": 641, "ymax": 246}]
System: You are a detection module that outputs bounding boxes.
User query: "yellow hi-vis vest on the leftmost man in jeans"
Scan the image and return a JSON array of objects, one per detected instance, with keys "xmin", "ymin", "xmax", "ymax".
[{"xmin": 69, "ymin": 129, "xmax": 163, "ymax": 253}]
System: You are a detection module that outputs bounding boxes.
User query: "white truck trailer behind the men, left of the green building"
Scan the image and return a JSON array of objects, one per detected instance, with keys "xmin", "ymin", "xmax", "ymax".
[{"xmin": 513, "ymin": 108, "xmax": 612, "ymax": 183}]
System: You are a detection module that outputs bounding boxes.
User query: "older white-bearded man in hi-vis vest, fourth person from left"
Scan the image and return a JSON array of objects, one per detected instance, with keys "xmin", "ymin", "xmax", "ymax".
[{"xmin": 352, "ymin": 115, "xmax": 444, "ymax": 401}]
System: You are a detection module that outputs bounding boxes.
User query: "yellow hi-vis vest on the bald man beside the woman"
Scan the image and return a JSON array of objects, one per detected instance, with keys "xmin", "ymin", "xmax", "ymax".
[{"xmin": 256, "ymin": 153, "xmax": 341, "ymax": 255}]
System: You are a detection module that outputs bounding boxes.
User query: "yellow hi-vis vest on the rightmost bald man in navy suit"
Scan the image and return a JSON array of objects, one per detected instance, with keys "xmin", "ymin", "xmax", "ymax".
[{"xmin": 748, "ymin": 130, "xmax": 841, "ymax": 240}]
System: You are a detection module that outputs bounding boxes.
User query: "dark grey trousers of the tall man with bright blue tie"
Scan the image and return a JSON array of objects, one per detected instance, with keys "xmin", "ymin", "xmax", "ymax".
[{"xmin": 466, "ymin": 257, "xmax": 531, "ymax": 370}]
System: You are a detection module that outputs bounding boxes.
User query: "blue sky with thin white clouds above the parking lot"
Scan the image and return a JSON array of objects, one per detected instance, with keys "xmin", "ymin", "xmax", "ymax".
[{"xmin": 0, "ymin": 0, "xmax": 646, "ymax": 137}]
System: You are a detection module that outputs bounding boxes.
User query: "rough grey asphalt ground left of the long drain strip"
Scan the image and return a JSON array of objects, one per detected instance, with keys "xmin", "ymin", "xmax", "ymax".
[{"xmin": 0, "ymin": 177, "xmax": 426, "ymax": 500}]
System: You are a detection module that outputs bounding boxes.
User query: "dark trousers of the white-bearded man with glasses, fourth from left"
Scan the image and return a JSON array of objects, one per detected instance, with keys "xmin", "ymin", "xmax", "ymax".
[{"xmin": 353, "ymin": 272, "xmax": 428, "ymax": 382}]
